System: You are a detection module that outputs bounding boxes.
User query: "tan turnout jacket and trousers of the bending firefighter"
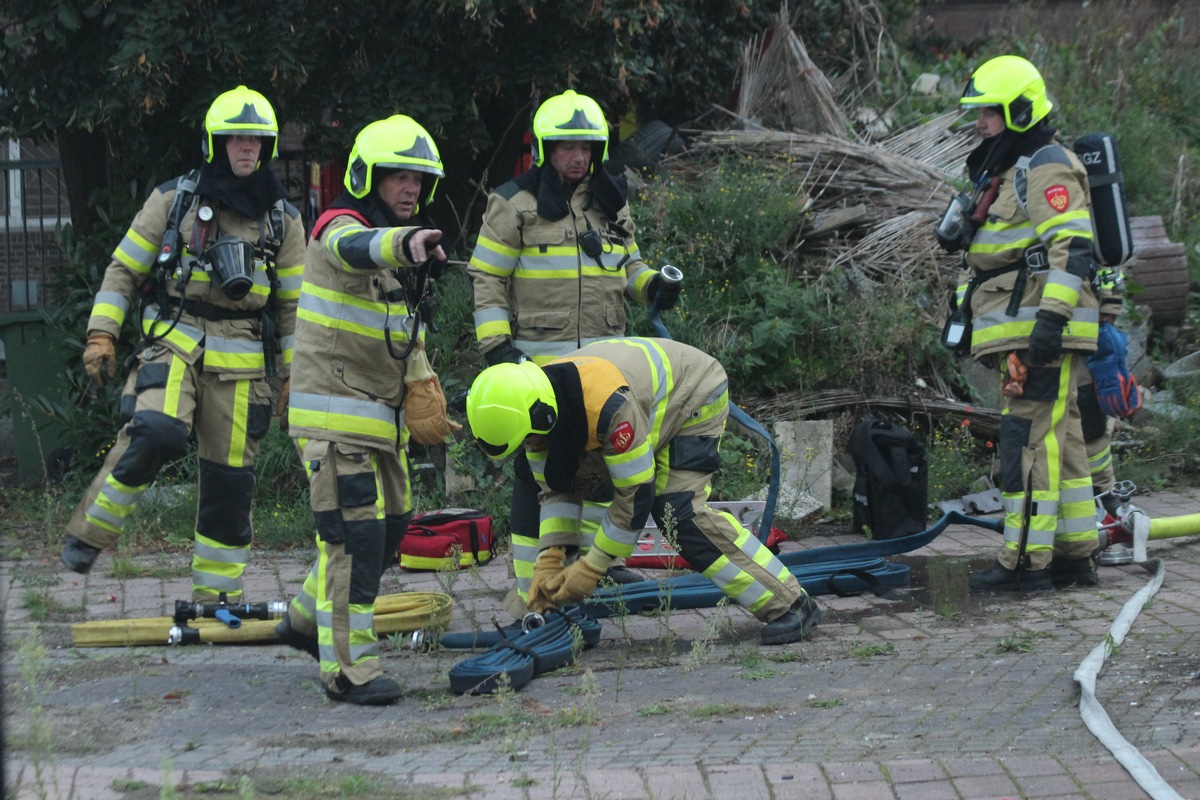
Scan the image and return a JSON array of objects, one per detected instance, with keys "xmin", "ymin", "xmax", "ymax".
[{"xmin": 527, "ymin": 338, "xmax": 804, "ymax": 621}]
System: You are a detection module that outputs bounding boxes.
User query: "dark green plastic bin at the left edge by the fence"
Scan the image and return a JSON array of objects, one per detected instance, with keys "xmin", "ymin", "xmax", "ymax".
[{"xmin": 0, "ymin": 311, "xmax": 66, "ymax": 486}]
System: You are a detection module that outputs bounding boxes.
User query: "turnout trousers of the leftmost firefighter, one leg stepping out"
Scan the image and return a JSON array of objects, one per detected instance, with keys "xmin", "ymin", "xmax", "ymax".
[{"xmin": 67, "ymin": 345, "xmax": 272, "ymax": 602}]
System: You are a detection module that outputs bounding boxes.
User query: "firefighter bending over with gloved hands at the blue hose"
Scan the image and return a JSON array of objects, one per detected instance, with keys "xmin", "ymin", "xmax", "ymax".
[{"xmin": 467, "ymin": 338, "xmax": 824, "ymax": 644}]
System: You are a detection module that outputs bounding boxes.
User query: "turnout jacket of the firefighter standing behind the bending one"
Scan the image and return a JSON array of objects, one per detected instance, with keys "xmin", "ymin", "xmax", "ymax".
[{"xmin": 467, "ymin": 178, "xmax": 656, "ymax": 363}]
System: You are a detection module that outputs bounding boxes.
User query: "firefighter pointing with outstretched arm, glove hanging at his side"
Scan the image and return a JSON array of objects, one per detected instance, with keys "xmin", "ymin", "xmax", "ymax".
[{"xmin": 276, "ymin": 115, "xmax": 461, "ymax": 705}]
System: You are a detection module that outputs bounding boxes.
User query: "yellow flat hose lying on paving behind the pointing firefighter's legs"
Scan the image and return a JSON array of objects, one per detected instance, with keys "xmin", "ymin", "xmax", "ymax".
[{"xmin": 71, "ymin": 591, "xmax": 451, "ymax": 648}]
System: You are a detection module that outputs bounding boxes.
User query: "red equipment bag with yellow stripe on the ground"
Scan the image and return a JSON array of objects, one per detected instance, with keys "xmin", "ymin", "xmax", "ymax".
[{"xmin": 398, "ymin": 509, "xmax": 496, "ymax": 570}]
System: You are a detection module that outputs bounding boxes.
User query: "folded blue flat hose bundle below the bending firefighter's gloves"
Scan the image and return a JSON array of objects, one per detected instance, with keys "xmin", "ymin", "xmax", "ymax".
[{"xmin": 450, "ymin": 607, "xmax": 600, "ymax": 694}]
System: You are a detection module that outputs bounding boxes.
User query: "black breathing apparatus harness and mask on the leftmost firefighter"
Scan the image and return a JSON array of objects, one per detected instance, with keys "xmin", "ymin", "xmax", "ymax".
[{"xmin": 137, "ymin": 176, "xmax": 286, "ymax": 378}]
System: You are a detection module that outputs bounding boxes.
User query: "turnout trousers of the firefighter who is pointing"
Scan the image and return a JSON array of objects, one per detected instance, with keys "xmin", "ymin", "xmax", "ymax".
[{"xmin": 280, "ymin": 439, "xmax": 413, "ymax": 691}]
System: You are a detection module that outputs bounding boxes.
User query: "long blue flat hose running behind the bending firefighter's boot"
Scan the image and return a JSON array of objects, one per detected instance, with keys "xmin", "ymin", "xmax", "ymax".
[{"xmin": 582, "ymin": 511, "xmax": 1004, "ymax": 619}]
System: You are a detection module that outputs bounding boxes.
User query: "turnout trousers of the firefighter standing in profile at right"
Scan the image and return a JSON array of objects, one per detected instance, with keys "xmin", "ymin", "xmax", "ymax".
[{"xmin": 1000, "ymin": 351, "xmax": 1099, "ymax": 570}]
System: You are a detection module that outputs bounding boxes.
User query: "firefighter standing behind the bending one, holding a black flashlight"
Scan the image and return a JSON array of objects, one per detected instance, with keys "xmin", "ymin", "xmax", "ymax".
[{"xmin": 467, "ymin": 90, "xmax": 679, "ymax": 616}]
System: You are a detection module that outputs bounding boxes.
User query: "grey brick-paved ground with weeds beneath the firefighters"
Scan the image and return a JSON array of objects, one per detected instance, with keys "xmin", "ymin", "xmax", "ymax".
[{"xmin": 0, "ymin": 492, "xmax": 1200, "ymax": 800}]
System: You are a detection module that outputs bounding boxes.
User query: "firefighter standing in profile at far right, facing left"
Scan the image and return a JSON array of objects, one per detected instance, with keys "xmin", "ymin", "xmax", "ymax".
[{"xmin": 938, "ymin": 55, "xmax": 1099, "ymax": 591}]
